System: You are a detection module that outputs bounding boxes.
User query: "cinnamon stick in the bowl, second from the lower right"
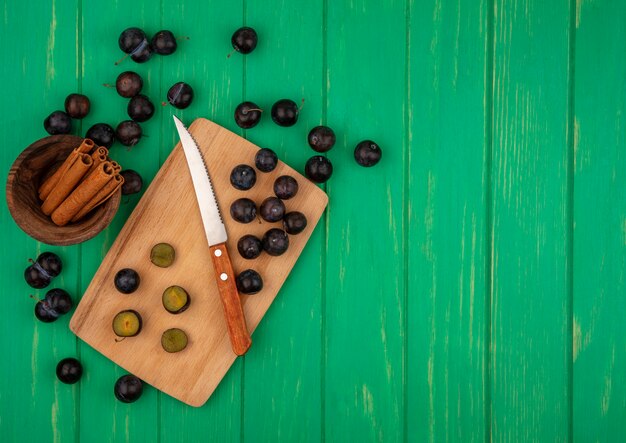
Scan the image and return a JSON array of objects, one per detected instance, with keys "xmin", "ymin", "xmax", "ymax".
[{"xmin": 52, "ymin": 162, "xmax": 113, "ymax": 226}]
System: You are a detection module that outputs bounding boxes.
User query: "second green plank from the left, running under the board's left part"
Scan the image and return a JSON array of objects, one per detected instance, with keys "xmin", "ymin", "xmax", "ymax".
[{"xmin": 79, "ymin": 2, "xmax": 162, "ymax": 441}]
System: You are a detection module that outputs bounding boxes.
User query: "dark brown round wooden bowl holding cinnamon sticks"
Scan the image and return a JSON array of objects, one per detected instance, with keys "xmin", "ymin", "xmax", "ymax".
[{"xmin": 6, "ymin": 135, "xmax": 122, "ymax": 246}]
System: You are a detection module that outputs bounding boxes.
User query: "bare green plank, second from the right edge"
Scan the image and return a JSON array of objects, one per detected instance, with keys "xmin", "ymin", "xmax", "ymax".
[{"xmin": 490, "ymin": 0, "xmax": 571, "ymax": 441}]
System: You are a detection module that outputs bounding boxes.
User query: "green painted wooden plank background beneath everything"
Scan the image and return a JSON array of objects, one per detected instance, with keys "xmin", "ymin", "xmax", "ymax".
[{"xmin": 0, "ymin": 0, "xmax": 626, "ymax": 443}]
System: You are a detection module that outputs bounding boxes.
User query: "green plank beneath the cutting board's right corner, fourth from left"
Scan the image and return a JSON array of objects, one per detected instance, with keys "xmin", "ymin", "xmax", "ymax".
[{"xmin": 240, "ymin": 0, "xmax": 324, "ymax": 442}]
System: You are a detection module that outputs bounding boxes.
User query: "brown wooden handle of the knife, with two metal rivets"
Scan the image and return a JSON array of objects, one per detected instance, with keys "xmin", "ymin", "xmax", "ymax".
[{"xmin": 209, "ymin": 243, "xmax": 252, "ymax": 355}]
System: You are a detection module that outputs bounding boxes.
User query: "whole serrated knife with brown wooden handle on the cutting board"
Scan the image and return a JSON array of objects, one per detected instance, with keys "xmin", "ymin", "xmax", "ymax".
[{"xmin": 174, "ymin": 116, "xmax": 252, "ymax": 355}]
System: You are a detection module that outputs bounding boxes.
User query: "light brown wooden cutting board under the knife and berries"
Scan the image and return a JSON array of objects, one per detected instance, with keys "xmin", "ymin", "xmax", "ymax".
[{"xmin": 70, "ymin": 119, "xmax": 328, "ymax": 406}]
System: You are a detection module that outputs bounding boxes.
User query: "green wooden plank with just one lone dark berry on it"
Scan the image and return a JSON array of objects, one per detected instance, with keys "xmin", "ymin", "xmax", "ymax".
[{"xmin": 323, "ymin": 0, "xmax": 408, "ymax": 442}]
